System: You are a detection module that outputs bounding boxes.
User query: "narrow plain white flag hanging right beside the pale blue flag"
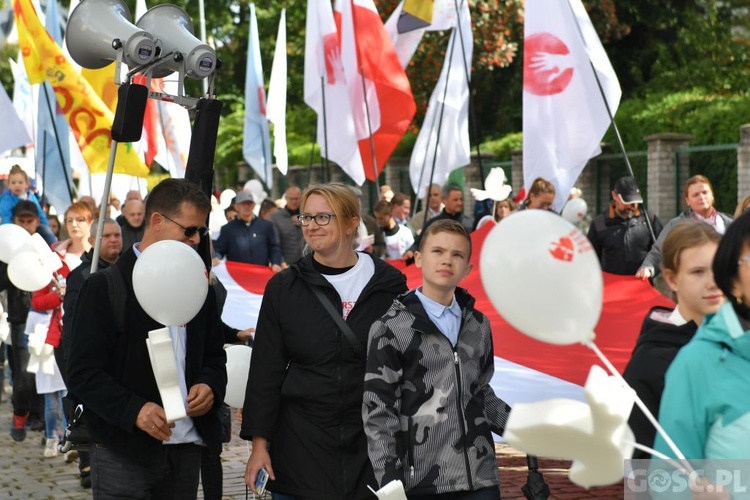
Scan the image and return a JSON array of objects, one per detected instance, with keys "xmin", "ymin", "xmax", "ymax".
[{"xmin": 266, "ymin": 9, "xmax": 289, "ymax": 175}]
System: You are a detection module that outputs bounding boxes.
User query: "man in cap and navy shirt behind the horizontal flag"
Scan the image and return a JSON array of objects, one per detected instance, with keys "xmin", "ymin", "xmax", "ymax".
[{"xmin": 214, "ymin": 191, "xmax": 281, "ymax": 273}]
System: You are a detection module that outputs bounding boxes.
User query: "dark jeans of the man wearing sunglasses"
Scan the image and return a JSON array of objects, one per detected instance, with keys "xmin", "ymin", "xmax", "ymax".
[{"xmin": 89, "ymin": 444, "xmax": 202, "ymax": 500}]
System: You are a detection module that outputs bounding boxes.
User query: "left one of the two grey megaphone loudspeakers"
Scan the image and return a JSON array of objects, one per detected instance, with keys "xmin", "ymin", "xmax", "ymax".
[{"xmin": 65, "ymin": 0, "xmax": 156, "ymax": 69}]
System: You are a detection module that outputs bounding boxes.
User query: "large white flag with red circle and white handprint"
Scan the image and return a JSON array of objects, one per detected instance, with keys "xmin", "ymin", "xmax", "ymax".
[{"xmin": 523, "ymin": 0, "xmax": 622, "ymax": 210}]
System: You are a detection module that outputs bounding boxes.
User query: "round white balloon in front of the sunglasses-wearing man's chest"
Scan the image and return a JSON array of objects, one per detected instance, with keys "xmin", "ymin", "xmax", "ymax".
[{"xmin": 133, "ymin": 240, "xmax": 208, "ymax": 326}]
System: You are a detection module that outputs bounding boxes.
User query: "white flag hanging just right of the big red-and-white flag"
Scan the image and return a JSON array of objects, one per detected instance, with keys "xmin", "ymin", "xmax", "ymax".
[{"xmin": 399, "ymin": 0, "xmax": 474, "ymax": 196}]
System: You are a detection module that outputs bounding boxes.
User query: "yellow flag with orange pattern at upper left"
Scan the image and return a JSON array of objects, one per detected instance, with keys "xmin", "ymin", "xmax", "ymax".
[{"xmin": 13, "ymin": 0, "xmax": 149, "ymax": 177}]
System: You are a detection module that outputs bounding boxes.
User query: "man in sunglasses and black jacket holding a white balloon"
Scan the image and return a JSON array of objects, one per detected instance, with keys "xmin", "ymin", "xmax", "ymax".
[{"xmin": 68, "ymin": 179, "xmax": 227, "ymax": 498}]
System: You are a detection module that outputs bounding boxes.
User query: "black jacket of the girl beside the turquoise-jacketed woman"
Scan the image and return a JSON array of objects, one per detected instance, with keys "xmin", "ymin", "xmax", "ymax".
[{"xmin": 623, "ymin": 306, "xmax": 698, "ymax": 458}]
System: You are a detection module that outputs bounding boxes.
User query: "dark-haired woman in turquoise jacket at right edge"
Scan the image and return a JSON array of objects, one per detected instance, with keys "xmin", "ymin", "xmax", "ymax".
[{"xmin": 654, "ymin": 214, "xmax": 750, "ymax": 460}]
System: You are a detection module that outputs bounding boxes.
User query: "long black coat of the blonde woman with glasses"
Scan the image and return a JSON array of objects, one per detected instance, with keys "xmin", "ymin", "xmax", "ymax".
[{"xmin": 240, "ymin": 253, "xmax": 406, "ymax": 500}]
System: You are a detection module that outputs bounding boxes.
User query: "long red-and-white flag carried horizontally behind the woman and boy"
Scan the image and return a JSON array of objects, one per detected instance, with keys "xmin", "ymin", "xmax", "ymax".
[{"xmin": 214, "ymin": 224, "xmax": 674, "ymax": 412}]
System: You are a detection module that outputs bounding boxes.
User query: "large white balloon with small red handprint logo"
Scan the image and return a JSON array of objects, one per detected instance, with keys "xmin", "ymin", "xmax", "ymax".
[{"xmin": 479, "ymin": 210, "xmax": 603, "ymax": 345}]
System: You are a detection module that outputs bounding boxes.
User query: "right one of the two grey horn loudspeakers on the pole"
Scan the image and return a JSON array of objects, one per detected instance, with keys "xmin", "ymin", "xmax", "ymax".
[{"xmin": 136, "ymin": 4, "xmax": 216, "ymax": 80}]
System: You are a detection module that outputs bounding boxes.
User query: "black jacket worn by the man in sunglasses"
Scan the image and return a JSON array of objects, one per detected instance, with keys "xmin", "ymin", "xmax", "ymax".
[{"xmin": 68, "ymin": 248, "xmax": 227, "ymax": 465}]
